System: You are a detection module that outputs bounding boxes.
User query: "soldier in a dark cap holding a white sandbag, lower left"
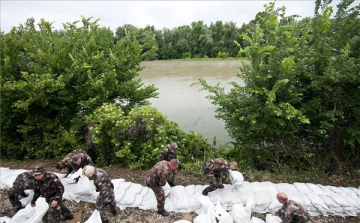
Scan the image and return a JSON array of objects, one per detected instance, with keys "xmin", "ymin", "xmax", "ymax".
[{"xmin": 31, "ymin": 166, "xmax": 74, "ymax": 223}]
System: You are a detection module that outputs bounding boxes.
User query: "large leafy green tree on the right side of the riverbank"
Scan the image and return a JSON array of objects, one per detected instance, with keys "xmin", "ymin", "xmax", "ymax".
[{"xmin": 199, "ymin": 1, "xmax": 360, "ymax": 171}]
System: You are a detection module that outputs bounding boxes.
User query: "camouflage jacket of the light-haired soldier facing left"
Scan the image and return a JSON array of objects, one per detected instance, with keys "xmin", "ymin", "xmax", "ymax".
[{"xmin": 89, "ymin": 168, "xmax": 114, "ymax": 197}]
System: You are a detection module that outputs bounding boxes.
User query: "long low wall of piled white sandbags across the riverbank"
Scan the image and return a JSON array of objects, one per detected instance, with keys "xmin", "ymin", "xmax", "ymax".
[{"xmin": 0, "ymin": 167, "xmax": 360, "ymax": 222}]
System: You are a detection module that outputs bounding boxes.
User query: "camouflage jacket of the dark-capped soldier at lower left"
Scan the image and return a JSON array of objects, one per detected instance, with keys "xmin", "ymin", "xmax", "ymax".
[{"xmin": 31, "ymin": 173, "xmax": 64, "ymax": 203}]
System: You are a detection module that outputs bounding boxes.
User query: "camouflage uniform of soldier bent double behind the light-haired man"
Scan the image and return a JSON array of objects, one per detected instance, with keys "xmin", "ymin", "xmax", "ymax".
[{"xmin": 60, "ymin": 149, "xmax": 94, "ymax": 176}]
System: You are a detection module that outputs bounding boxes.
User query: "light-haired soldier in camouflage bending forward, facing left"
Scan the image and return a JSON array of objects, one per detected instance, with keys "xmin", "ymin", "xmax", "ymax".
[{"xmin": 83, "ymin": 165, "xmax": 117, "ymax": 223}]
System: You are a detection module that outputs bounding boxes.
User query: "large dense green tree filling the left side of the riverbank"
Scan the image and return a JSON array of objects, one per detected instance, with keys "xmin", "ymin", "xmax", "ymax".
[{"xmin": 0, "ymin": 18, "xmax": 156, "ymax": 159}]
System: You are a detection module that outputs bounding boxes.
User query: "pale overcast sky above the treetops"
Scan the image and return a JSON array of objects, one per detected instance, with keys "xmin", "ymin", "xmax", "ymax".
[{"xmin": 1, "ymin": 0, "xmax": 354, "ymax": 32}]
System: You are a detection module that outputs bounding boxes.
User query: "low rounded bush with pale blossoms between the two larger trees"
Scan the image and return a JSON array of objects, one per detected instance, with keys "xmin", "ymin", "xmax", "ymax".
[{"xmin": 87, "ymin": 104, "xmax": 215, "ymax": 168}]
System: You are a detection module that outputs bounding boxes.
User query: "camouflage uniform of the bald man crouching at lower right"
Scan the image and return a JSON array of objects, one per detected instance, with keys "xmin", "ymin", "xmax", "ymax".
[{"xmin": 275, "ymin": 200, "xmax": 311, "ymax": 223}]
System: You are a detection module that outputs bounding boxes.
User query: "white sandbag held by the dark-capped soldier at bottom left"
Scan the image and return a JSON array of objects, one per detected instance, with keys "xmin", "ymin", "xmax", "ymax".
[{"xmin": 10, "ymin": 197, "xmax": 49, "ymax": 223}]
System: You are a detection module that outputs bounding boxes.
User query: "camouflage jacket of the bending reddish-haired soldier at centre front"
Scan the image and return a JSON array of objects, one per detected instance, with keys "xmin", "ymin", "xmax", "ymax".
[{"xmin": 146, "ymin": 160, "xmax": 173, "ymax": 186}]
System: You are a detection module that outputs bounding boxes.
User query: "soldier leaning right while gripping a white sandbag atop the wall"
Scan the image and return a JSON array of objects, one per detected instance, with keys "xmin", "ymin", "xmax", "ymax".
[{"xmin": 202, "ymin": 158, "xmax": 237, "ymax": 196}]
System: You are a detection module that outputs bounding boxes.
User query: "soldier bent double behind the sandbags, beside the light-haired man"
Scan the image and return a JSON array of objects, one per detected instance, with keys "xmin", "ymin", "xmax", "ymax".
[{"xmin": 55, "ymin": 149, "xmax": 94, "ymax": 177}]
